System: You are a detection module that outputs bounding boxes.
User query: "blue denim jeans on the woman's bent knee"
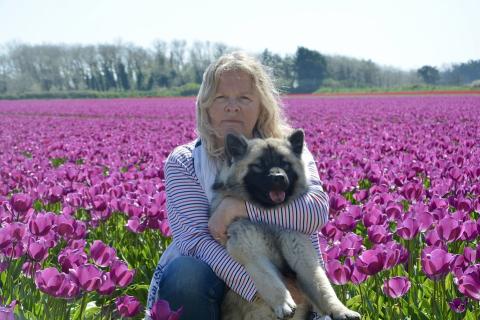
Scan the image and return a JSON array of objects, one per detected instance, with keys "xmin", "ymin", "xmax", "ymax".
[{"xmin": 152, "ymin": 256, "xmax": 226, "ymax": 320}]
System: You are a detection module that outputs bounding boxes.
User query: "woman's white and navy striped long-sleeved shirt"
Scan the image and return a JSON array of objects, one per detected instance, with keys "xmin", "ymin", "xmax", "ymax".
[{"xmin": 164, "ymin": 141, "xmax": 329, "ymax": 301}]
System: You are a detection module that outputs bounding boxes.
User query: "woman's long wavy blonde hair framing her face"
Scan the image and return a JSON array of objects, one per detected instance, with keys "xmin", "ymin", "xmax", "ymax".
[{"xmin": 196, "ymin": 52, "xmax": 292, "ymax": 157}]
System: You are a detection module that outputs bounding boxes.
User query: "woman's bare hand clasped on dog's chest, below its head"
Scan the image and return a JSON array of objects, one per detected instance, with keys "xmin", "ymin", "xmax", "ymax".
[{"xmin": 208, "ymin": 197, "xmax": 248, "ymax": 246}]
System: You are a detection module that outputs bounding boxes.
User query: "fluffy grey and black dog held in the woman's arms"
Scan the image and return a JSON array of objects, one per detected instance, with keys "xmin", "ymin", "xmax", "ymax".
[{"xmin": 211, "ymin": 130, "xmax": 360, "ymax": 320}]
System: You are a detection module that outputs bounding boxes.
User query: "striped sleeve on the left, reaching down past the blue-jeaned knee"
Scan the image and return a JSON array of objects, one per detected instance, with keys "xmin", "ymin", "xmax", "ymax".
[{"xmin": 164, "ymin": 147, "xmax": 256, "ymax": 301}]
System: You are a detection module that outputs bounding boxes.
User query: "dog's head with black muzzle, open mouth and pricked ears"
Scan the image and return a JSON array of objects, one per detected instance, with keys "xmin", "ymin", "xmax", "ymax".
[{"xmin": 213, "ymin": 130, "xmax": 306, "ymax": 208}]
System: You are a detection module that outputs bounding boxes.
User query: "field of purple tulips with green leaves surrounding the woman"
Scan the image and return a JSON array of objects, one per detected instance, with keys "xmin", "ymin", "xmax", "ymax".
[{"xmin": 0, "ymin": 94, "xmax": 480, "ymax": 320}]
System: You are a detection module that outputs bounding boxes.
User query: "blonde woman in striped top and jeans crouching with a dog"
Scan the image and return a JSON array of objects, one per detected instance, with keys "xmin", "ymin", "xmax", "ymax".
[{"xmin": 147, "ymin": 53, "xmax": 328, "ymax": 320}]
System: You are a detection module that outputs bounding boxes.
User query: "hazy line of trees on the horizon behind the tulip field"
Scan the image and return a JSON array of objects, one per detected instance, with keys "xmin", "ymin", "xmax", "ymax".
[{"xmin": 0, "ymin": 40, "xmax": 480, "ymax": 94}]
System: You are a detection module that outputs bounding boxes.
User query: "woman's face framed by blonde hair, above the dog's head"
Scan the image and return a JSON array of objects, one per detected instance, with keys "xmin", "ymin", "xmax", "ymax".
[{"xmin": 208, "ymin": 70, "xmax": 260, "ymax": 145}]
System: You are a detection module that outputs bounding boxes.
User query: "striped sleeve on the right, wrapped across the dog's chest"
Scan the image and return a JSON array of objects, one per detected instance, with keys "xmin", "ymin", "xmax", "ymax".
[{"xmin": 245, "ymin": 146, "xmax": 329, "ymax": 235}]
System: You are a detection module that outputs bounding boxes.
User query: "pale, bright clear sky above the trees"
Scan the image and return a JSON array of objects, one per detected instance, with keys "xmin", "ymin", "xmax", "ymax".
[{"xmin": 0, "ymin": 0, "xmax": 480, "ymax": 70}]
